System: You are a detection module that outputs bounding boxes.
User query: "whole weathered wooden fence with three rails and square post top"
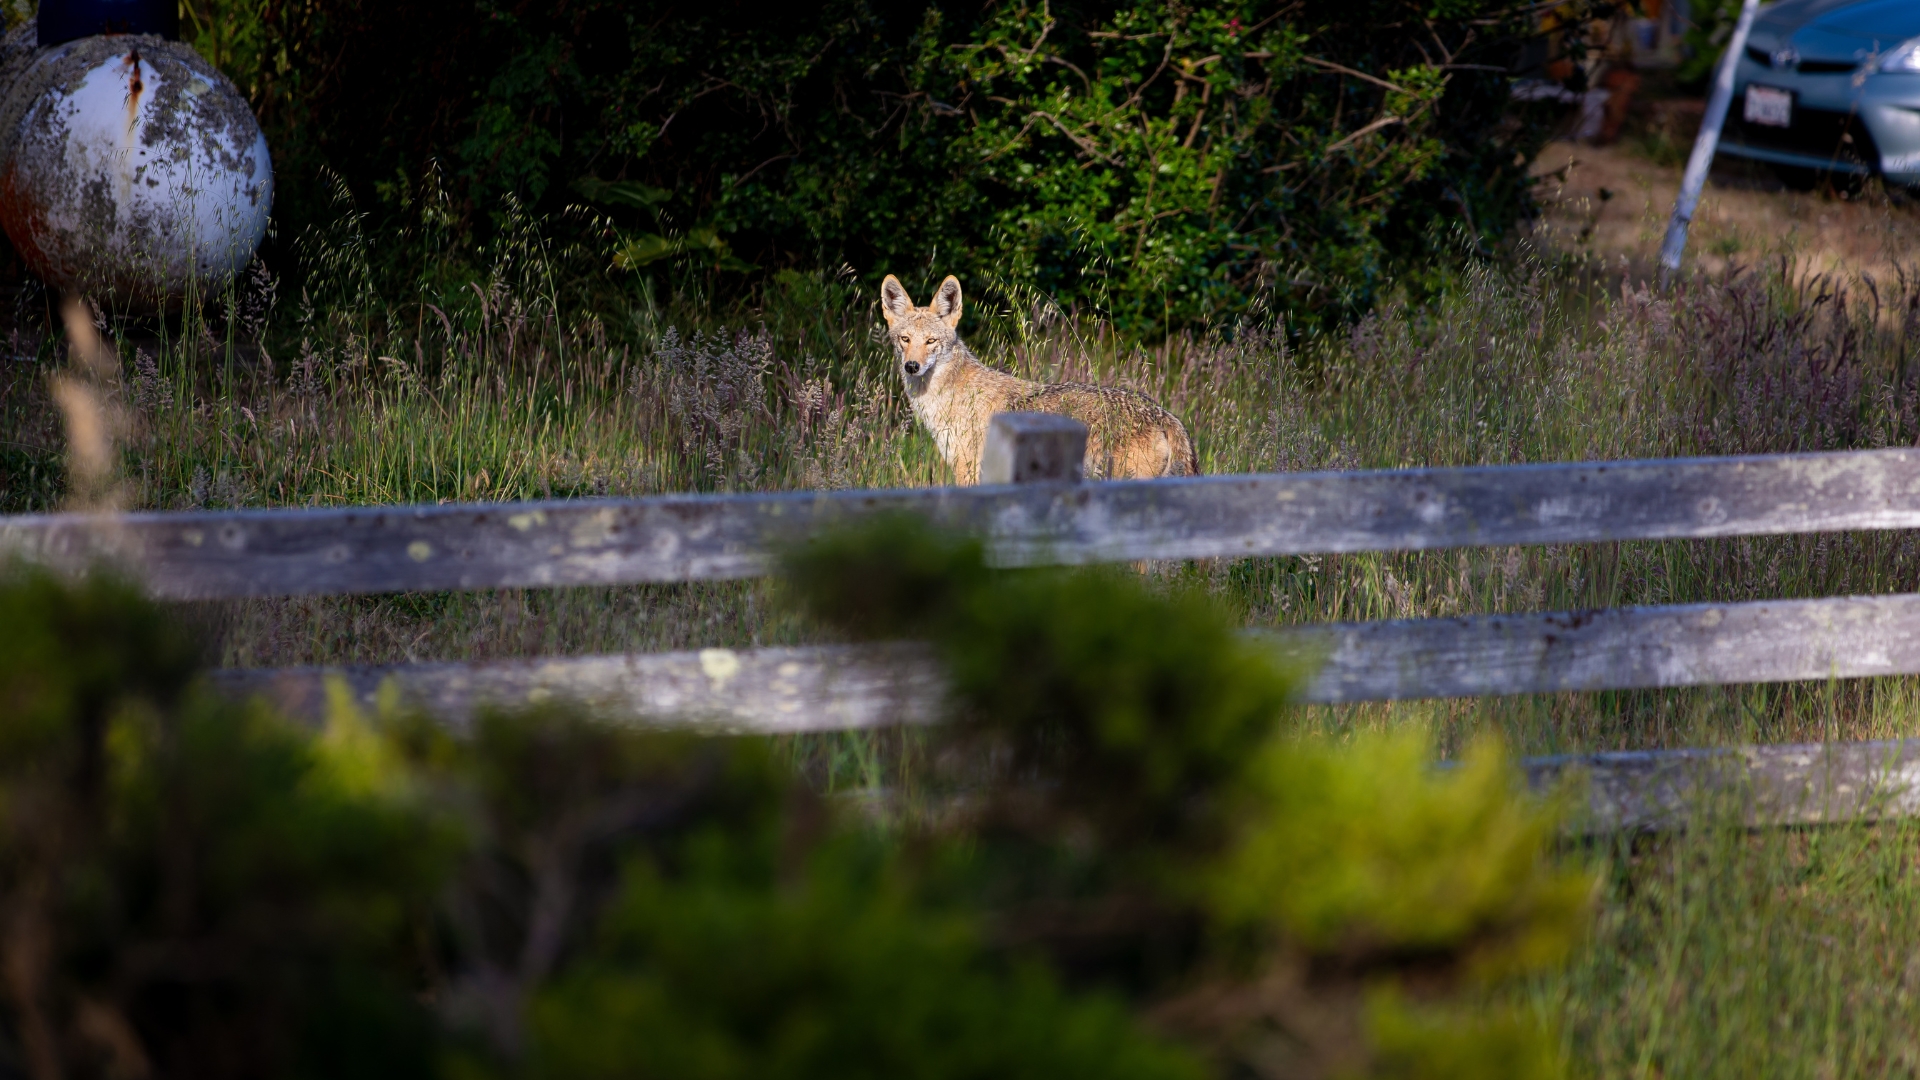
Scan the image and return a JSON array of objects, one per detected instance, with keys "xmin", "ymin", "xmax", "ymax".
[{"xmin": 11, "ymin": 415, "xmax": 1920, "ymax": 826}]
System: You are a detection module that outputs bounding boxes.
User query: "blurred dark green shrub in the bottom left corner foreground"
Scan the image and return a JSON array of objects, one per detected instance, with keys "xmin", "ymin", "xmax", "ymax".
[{"xmin": 0, "ymin": 557, "xmax": 445, "ymax": 1080}]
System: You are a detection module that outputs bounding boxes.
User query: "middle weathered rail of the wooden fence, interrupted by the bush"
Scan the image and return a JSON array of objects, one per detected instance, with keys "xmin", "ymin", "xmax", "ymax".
[{"xmin": 223, "ymin": 594, "xmax": 1920, "ymax": 718}]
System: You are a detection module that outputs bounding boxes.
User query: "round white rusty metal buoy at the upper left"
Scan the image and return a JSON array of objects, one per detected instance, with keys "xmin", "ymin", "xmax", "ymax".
[{"xmin": 0, "ymin": 25, "xmax": 273, "ymax": 309}]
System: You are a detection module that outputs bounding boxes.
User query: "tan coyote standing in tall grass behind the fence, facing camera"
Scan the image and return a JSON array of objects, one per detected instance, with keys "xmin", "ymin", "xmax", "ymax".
[{"xmin": 879, "ymin": 273, "xmax": 1200, "ymax": 484}]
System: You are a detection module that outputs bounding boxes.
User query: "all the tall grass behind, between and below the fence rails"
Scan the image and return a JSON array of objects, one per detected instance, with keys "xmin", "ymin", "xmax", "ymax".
[{"xmin": 0, "ymin": 219, "xmax": 1920, "ymax": 1076}]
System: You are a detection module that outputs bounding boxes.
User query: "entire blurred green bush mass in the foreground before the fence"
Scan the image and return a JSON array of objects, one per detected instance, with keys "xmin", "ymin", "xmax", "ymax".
[{"xmin": 0, "ymin": 521, "xmax": 1590, "ymax": 1080}]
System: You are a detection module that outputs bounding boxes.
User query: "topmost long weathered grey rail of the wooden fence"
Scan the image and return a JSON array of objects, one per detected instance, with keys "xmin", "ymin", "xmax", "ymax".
[{"xmin": 11, "ymin": 450, "xmax": 1920, "ymax": 600}]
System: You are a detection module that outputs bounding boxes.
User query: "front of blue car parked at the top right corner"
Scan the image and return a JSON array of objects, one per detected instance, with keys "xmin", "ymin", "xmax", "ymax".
[{"xmin": 1720, "ymin": 0, "xmax": 1920, "ymax": 188}]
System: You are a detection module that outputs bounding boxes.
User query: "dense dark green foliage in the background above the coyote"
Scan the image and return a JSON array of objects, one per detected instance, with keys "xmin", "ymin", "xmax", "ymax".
[{"xmin": 186, "ymin": 0, "xmax": 1540, "ymax": 329}]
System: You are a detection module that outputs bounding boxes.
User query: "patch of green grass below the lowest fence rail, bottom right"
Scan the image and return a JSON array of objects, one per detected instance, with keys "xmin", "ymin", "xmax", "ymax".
[{"xmin": 1532, "ymin": 821, "xmax": 1920, "ymax": 1078}]
